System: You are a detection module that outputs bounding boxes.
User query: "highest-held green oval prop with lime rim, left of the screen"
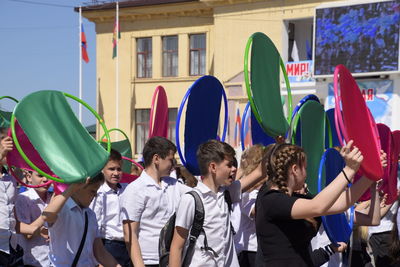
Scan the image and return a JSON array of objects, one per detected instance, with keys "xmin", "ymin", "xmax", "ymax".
[{"xmin": 244, "ymin": 32, "xmax": 292, "ymax": 137}]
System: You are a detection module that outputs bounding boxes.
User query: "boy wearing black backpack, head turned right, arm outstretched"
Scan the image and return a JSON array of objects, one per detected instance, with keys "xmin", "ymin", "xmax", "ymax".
[{"xmin": 169, "ymin": 140, "xmax": 265, "ymax": 267}]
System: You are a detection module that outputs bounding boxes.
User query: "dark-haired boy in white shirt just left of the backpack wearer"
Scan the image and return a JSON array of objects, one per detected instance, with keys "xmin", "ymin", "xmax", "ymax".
[{"xmin": 121, "ymin": 137, "xmax": 190, "ymax": 267}]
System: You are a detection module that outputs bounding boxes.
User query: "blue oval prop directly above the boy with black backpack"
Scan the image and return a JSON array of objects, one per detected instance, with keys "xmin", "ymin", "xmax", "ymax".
[{"xmin": 175, "ymin": 76, "xmax": 228, "ymax": 175}]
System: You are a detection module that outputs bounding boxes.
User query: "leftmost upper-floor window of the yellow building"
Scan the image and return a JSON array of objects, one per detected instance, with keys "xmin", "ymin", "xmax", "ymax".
[{"xmin": 136, "ymin": 37, "xmax": 152, "ymax": 78}]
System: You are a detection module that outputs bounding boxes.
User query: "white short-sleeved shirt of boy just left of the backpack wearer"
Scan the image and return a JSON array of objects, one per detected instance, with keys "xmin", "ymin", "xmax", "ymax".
[{"xmin": 121, "ymin": 171, "xmax": 191, "ymax": 265}]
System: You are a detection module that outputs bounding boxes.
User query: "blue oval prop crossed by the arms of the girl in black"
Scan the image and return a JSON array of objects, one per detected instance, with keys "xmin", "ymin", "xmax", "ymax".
[{"xmin": 318, "ymin": 148, "xmax": 354, "ymax": 244}]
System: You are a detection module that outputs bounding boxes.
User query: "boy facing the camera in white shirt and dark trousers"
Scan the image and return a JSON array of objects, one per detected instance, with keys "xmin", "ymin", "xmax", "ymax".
[{"xmin": 90, "ymin": 149, "xmax": 132, "ymax": 267}]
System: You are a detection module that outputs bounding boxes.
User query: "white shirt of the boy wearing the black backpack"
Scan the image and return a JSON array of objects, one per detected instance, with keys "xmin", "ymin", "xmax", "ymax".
[{"xmin": 175, "ymin": 181, "xmax": 241, "ymax": 267}]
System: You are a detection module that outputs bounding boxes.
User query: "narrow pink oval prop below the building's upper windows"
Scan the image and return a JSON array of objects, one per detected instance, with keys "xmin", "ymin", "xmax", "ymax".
[{"xmin": 149, "ymin": 85, "xmax": 169, "ymax": 138}]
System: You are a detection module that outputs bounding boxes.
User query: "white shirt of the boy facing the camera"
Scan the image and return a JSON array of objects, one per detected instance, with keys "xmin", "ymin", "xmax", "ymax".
[{"xmin": 89, "ymin": 182, "xmax": 127, "ymax": 241}]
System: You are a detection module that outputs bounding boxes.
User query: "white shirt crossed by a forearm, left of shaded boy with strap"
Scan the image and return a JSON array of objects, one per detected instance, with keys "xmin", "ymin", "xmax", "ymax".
[{"xmin": 15, "ymin": 188, "xmax": 51, "ymax": 266}]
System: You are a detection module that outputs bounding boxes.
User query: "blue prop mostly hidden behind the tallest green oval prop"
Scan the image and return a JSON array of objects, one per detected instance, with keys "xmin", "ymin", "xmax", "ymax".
[{"xmin": 240, "ymin": 102, "xmax": 275, "ymax": 150}]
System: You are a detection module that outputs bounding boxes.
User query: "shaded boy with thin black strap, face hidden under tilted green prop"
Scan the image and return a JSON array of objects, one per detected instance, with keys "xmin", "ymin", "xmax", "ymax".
[{"xmin": 42, "ymin": 173, "xmax": 121, "ymax": 267}]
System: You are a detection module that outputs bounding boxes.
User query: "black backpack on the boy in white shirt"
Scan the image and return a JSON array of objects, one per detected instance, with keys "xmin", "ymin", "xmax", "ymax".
[{"xmin": 158, "ymin": 191, "xmax": 218, "ymax": 267}]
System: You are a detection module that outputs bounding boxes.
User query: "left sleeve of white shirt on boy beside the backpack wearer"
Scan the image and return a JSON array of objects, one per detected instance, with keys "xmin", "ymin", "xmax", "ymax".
[{"xmin": 120, "ymin": 186, "xmax": 146, "ymax": 222}]
